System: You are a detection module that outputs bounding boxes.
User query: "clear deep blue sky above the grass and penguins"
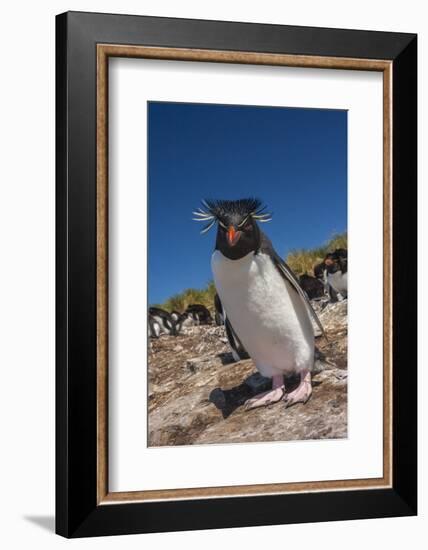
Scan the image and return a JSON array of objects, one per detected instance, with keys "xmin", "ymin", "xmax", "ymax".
[{"xmin": 148, "ymin": 102, "xmax": 347, "ymax": 304}]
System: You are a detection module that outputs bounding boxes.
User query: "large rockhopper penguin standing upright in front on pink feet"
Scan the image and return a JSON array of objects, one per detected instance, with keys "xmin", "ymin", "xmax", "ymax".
[{"xmin": 194, "ymin": 198, "xmax": 324, "ymax": 409}]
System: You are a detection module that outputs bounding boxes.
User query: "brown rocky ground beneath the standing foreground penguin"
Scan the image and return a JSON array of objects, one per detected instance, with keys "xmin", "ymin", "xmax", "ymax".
[{"xmin": 148, "ymin": 300, "xmax": 347, "ymax": 446}]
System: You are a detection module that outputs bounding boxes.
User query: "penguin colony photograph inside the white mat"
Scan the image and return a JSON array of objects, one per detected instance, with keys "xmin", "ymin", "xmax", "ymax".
[{"xmin": 147, "ymin": 101, "xmax": 352, "ymax": 447}]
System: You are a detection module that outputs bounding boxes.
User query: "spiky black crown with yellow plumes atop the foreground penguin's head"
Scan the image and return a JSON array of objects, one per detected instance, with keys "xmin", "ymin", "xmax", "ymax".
[{"xmin": 193, "ymin": 197, "xmax": 272, "ymax": 233}]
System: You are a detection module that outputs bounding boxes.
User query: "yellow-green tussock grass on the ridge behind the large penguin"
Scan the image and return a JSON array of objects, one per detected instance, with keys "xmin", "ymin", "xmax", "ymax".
[{"xmin": 152, "ymin": 233, "xmax": 348, "ymax": 313}]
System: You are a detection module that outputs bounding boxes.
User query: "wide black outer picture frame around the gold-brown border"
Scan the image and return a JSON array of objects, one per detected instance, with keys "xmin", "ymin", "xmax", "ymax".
[{"xmin": 56, "ymin": 12, "xmax": 417, "ymax": 537}]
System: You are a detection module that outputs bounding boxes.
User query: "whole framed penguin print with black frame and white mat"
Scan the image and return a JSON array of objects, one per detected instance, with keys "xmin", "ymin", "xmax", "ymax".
[{"xmin": 56, "ymin": 12, "xmax": 417, "ymax": 537}]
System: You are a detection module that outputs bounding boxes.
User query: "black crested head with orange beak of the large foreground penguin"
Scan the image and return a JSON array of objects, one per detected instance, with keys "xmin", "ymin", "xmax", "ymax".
[{"xmin": 194, "ymin": 198, "xmax": 271, "ymax": 260}]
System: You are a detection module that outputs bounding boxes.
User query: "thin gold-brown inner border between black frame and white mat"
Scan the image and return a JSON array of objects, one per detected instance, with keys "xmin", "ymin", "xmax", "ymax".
[{"xmin": 96, "ymin": 44, "xmax": 392, "ymax": 505}]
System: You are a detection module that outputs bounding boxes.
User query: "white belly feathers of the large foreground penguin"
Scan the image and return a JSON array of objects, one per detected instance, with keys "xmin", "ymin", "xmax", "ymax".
[{"xmin": 211, "ymin": 250, "xmax": 314, "ymax": 376}]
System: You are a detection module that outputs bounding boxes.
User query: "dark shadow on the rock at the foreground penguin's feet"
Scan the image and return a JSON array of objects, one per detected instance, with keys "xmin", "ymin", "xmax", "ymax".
[{"xmin": 208, "ymin": 372, "xmax": 300, "ymax": 419}]
